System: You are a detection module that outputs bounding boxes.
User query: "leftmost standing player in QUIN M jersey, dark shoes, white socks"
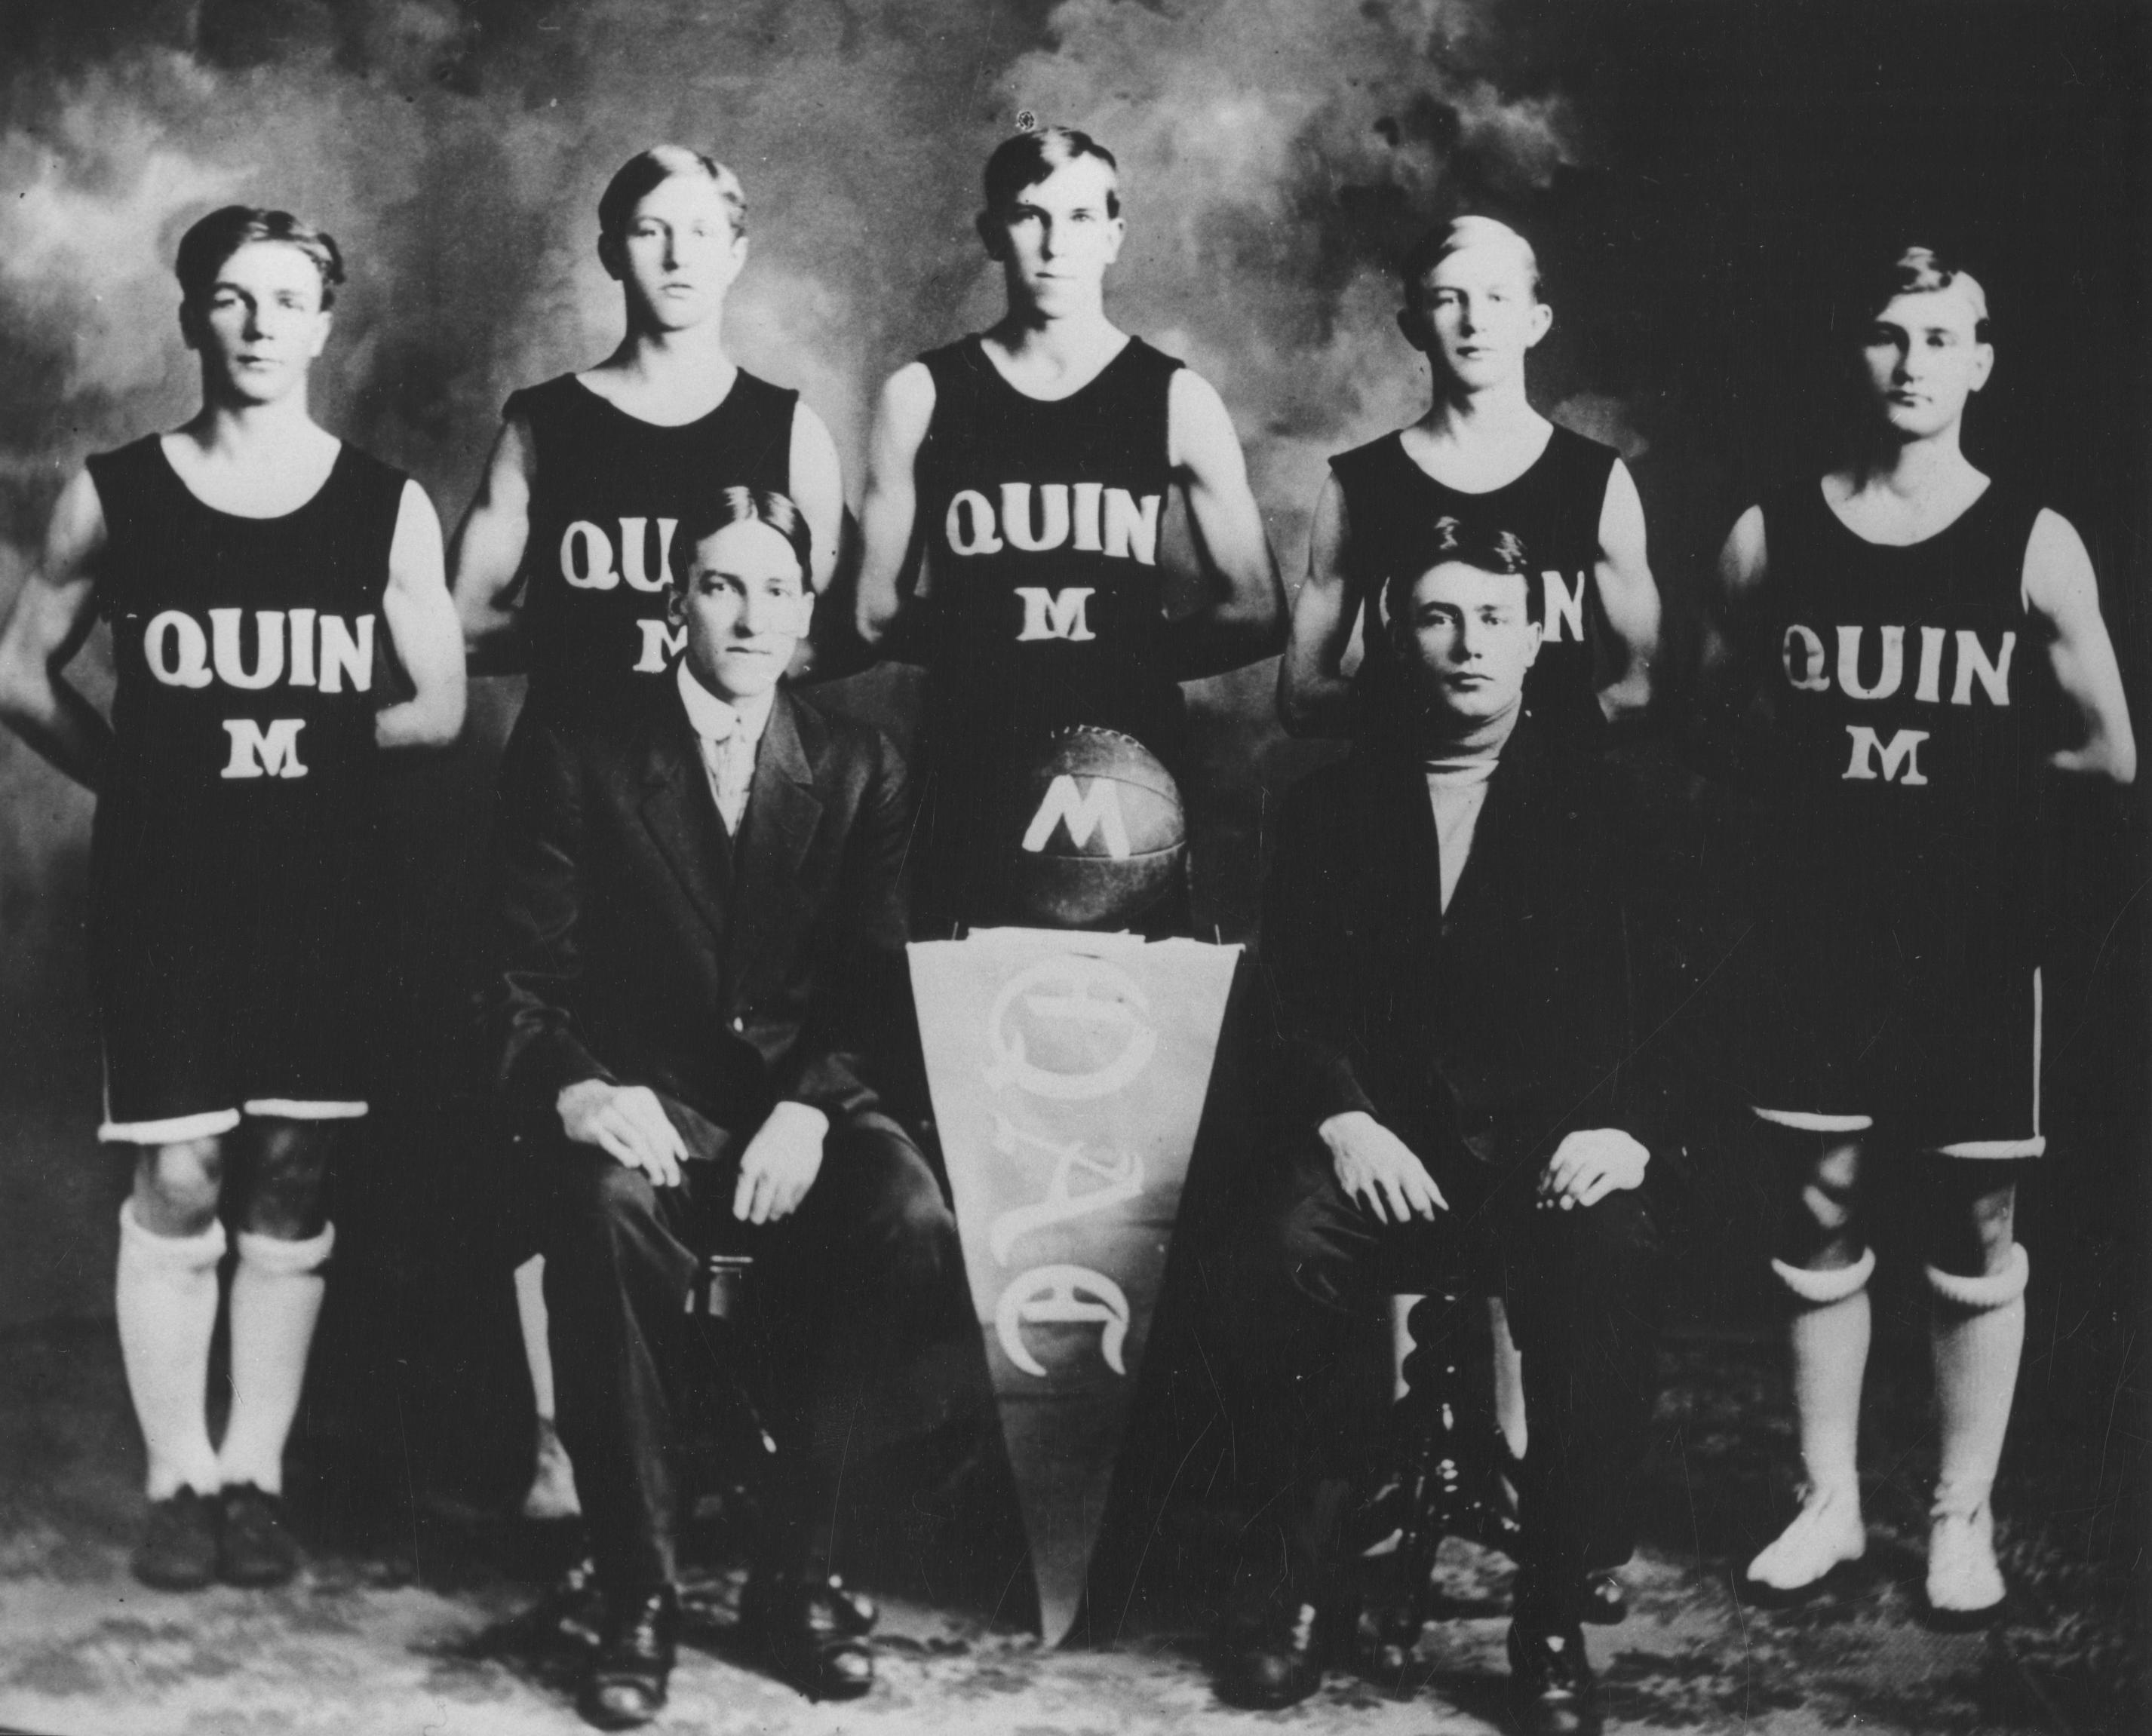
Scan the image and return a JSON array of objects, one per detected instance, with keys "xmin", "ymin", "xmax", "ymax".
[{"xmin": 0, "ymin": 204, "xmax": 462, "ymax": 1587}]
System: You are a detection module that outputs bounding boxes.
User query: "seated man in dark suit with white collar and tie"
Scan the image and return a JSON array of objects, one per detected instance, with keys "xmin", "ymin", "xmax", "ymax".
[{"xmin": 497, "ymin": 489, "xmax": 959, "ymax": 1728}]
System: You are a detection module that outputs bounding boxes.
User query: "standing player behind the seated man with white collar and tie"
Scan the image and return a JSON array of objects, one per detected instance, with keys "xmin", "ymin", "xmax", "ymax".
[{"xmin": 452, "ymin": 144, "xmax": 843, "ymax": 1519}]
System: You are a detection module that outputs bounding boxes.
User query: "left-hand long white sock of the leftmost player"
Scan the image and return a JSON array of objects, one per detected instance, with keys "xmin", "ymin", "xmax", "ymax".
[{"xmin": 112, "ymin": 1201, "xmax": 224, "ymax": 1501}]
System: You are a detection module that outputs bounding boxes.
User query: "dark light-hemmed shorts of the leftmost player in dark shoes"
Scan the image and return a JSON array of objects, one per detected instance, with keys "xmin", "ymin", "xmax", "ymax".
[{"xmin": 91, "ymin": 826, "xmax": 381, "ymax": 1145}]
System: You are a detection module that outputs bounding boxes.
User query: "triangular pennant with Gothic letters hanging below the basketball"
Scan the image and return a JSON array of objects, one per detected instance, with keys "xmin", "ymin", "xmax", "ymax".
[{"xmin": 910, "ymin": 929, "xmax": 1239, "ymax": 1646}]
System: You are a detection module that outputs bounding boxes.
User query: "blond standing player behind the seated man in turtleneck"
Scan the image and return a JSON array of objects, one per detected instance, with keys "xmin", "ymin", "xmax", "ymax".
[{"xmin": 1279, "ymin": 217, "xmax": 1659, "ymax": 747}]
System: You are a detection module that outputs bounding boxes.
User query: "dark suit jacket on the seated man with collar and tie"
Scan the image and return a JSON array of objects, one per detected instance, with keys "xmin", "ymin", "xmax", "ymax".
[{"xmin": 495, "ymin": 686, "xmax": 913, "ymax": 1155}]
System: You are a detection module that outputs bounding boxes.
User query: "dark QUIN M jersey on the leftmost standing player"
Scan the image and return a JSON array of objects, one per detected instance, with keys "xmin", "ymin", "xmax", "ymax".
[{"xmin": 88, "ymin": 437, "xmax": 404, "ymax": 843}]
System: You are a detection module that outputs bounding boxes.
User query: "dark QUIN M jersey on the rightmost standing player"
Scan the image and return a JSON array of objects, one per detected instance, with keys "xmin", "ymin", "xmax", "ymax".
[{"xmin": 1763, "ymin": 477, "xmax": 2059, "ymax": 929}]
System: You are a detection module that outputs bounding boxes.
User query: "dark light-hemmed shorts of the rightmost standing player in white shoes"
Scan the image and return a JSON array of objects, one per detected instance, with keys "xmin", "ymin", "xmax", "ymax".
[{"xmin": 1741, "ymin": 882, "xmax": 2046, "ymax": 1160}]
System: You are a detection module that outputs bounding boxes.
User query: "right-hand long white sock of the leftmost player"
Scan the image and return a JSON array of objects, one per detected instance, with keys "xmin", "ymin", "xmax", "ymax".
[{"xmin": 217, "ymin": 1224, "xmax": 336, "ymax": 1495}]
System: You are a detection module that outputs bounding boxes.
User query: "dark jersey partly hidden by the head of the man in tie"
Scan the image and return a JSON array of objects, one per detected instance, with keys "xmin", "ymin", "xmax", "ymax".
[{"xmin": 502, "ymin": 368, "xmax": 798, "ymax": 719}]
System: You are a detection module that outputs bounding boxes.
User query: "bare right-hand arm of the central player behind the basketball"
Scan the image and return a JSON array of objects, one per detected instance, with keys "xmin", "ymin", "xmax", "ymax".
[{"xmin": 1166, "ymin": 368, "xmax": 1285, "ymax": 682}]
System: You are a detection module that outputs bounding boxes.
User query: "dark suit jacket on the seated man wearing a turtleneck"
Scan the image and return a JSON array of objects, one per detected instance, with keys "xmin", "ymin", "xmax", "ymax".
[{"xmin": 1263, "ymin": 719, "xmax": 1711, "ymax": 1173}]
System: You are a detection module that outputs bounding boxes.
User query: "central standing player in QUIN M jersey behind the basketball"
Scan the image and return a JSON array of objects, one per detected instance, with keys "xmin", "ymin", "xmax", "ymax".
[{"xmin": 856, "ymin": 127, "xmax": 1285, "ymax": 931}]
